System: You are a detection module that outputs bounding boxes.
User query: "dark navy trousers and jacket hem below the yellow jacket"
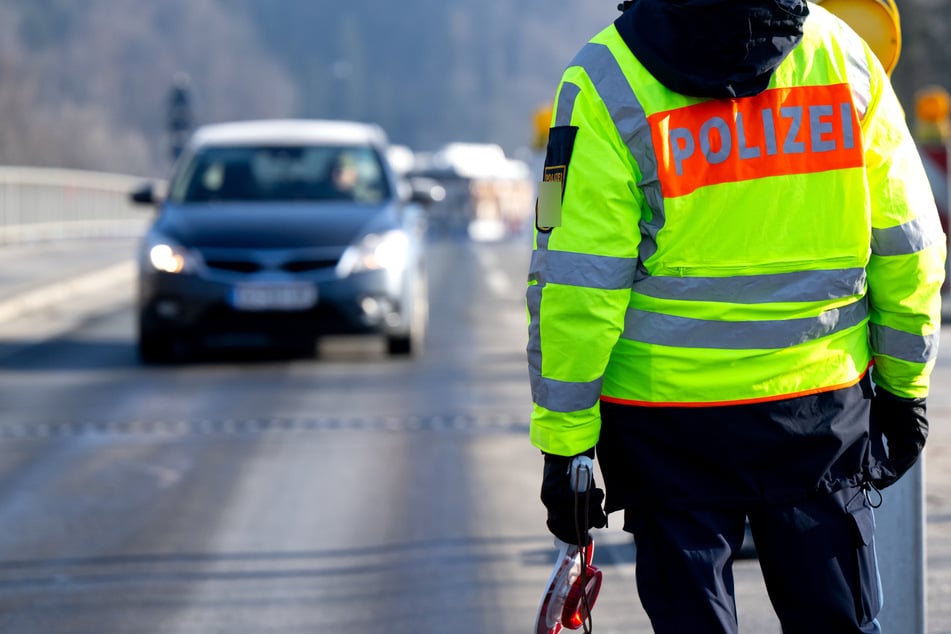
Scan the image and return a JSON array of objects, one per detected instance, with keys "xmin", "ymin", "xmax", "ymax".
[{"xmin": 597, "ymin": 381, "xmax": 882, "ymax": 634}]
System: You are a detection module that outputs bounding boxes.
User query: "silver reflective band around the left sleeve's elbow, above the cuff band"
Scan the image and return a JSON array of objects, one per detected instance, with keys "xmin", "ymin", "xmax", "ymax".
[{"xmin": 529, "ymin": 251, "xmax": 637, "ymax": 290}]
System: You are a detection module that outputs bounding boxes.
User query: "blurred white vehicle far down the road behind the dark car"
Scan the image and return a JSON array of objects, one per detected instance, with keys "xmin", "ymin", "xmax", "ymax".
[{"xmin": 408, "ymin": 143, "xmax": 535, "ymax": 241}]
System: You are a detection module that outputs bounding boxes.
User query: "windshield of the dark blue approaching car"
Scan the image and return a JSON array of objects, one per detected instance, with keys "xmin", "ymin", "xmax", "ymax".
[{"xmin": 170, "ymin": 145, "xmax": 390, "ymax": 203}]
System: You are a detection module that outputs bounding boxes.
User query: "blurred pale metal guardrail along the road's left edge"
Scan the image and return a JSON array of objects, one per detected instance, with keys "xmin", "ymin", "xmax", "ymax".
[{"xmin": 0, "ymin": 166, "xmax": 151, "ymax": 245}]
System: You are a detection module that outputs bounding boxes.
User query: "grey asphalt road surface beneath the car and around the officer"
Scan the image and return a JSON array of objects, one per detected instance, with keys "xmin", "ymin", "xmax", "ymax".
[{"xmin": 0, "ymin": 235, "xmax": 951, "ymax": 634}]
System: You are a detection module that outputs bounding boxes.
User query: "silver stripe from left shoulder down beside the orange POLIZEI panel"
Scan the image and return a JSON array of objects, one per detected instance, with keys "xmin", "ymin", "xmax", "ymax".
[{"xmin": 571, "ymin": 42, "xmax": 665, "ymax": 262}]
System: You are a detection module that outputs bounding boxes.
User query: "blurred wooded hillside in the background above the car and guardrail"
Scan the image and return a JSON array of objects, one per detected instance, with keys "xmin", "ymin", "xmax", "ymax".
[{"xmin": 0, "ymin": 0, "xmax": 951, "ymax": 175}]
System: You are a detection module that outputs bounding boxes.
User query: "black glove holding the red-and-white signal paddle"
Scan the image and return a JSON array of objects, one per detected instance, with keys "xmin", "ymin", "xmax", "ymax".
[{"xmin": 542, "ymin": 449, "xmax": 608, "ymax": 546}]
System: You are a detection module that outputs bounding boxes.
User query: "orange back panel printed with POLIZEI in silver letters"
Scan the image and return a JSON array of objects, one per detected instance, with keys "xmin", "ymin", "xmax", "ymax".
[{"xmin": 648, "ymin": 84, "xmax": 862, "ymax": 198}]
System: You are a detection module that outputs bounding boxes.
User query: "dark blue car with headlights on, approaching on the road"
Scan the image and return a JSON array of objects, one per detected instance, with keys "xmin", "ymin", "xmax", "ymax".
[{"xmin": 131, "ymin": 120, "xmax": 429, "ymax": 362}]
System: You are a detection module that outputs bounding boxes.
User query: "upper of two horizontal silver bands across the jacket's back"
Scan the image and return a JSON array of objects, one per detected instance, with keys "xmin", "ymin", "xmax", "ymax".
[{"xmin": 634, "ymin": 268, "xmax": 865, "ymax": 304}]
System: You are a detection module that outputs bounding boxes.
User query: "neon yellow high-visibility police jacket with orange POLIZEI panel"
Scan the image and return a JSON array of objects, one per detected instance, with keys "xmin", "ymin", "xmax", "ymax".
[{"xmin": 526, "ymin": 5, "xmax": 946, "ymax": 455}]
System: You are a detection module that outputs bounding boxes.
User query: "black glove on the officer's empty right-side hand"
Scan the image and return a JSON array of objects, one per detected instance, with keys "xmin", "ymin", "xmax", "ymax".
[{"xmin": 870, "ymin": 387, "xmax": 928, "ymax": 490}]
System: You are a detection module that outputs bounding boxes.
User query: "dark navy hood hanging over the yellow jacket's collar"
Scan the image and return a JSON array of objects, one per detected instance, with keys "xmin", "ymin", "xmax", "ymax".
[{"xmin": 614, "ymin": 0, "xmax": 809, "ymax": 98}]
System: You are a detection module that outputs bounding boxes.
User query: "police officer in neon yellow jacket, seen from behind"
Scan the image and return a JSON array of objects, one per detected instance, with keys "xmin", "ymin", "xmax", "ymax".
[{"xmin": 526, "ymin": 0, "xmax": 947, "ymax": 634}]
